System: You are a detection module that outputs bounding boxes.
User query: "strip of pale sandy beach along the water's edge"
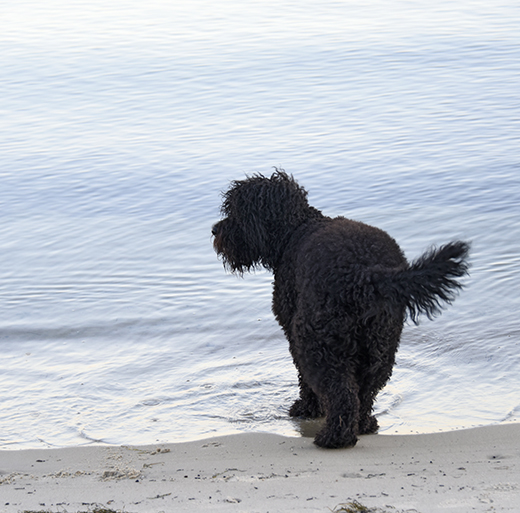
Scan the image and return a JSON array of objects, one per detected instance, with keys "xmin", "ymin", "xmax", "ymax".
[{"xmin": 0, "ymin": 424, "xmax": 520, "ymax": 513}]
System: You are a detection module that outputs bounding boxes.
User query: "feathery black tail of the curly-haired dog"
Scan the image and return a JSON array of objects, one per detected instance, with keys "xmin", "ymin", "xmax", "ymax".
[{"xmin": 372, "ymin": 241, "xmax": 470, "ymax": 323}]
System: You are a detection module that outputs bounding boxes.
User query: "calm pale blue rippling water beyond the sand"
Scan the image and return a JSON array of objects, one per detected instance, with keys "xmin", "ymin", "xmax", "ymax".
[{"xmin": 0, "ymin": 0, "xmax": 520, "ymax": 448}]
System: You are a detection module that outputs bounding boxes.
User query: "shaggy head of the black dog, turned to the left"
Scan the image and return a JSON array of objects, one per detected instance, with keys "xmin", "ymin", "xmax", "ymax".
[{"xmin": 212, "ymin": 170, "xmax": 321, "ymax": 273}]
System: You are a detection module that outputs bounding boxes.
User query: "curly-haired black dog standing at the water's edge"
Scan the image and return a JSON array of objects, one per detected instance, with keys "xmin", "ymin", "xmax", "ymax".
[{"xmin": 212, "ymin": 170, "xmax": 469, "ymax": 448}]
